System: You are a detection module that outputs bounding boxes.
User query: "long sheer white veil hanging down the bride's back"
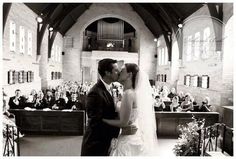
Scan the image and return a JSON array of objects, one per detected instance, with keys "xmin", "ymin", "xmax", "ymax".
[{"xmin": 135, "ymin": 70, "xmax": 158, "ymax": 155}]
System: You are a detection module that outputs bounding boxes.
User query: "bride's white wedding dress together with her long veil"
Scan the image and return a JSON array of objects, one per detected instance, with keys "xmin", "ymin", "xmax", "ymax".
[{"xmin": 110, "ymin": 71, "xmax": 158, "ymax": 156}]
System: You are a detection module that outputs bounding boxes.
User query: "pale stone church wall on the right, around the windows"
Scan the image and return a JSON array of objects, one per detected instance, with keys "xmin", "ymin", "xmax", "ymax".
[{"xmin": 156, "ymin": 3, "xmax": 233, "ymax": 112}]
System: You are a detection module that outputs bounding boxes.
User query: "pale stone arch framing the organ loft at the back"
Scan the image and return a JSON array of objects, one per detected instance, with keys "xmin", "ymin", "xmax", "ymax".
[{"xmin": 64, "ymin": 3, "xmax": 156, "ymax": 80}]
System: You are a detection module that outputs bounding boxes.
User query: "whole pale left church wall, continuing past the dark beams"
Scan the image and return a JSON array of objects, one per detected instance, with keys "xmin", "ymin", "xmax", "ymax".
[{"xmin": 1, "ymin": 3, "xmax": 63, "ymax": 96}]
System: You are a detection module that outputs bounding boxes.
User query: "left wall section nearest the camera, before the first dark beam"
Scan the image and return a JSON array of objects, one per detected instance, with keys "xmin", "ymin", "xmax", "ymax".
[{"xmin": 1, "ymin": 3, "xmax": 41, "ymax": 96}]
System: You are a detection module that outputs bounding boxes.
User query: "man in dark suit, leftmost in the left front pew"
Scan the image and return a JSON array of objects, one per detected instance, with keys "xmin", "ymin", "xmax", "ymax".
[{"xmin": 8, "ymin": 89, "xmax": 26, "ymax": 109}]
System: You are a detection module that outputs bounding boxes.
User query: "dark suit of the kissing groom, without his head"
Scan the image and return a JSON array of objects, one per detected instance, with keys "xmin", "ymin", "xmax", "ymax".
[{"xmin": 81, "ymin": 80, "xmax": 120, "ymax": 156}]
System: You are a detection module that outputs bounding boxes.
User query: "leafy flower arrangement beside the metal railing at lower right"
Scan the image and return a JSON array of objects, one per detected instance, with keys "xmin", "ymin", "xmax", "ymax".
[{"xmin": 173, "ymin": 116, "xmax": 205, "ymax": 156}]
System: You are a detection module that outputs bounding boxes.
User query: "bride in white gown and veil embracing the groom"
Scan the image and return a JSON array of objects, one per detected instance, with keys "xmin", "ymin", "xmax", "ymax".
[{"xmin": 103, "ymin": 63, "xmax": 158, "ymax": 156}]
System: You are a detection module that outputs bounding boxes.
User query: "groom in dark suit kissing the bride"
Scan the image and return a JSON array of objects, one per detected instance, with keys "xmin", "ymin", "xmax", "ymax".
[{"xmin": 81, "ymin": 59, "xmax": 120, "ymax": 156}]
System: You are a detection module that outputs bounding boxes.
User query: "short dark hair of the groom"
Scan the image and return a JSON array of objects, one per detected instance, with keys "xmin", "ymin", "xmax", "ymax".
[{"xmin": 98, "ymin": 58, "xmax": 117, "ymax": 77}]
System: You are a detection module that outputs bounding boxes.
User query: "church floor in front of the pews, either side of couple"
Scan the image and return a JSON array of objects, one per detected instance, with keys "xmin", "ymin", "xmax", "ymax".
[{"xmin": 20, "ymin": 135, "xmax": 177, "ymax": 157}]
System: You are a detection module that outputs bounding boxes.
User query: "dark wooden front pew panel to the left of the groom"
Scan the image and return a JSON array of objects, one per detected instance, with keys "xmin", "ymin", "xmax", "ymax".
[{"xmin": 9, "ymin": 109, "xmax": 85, "ymax": 135}]
